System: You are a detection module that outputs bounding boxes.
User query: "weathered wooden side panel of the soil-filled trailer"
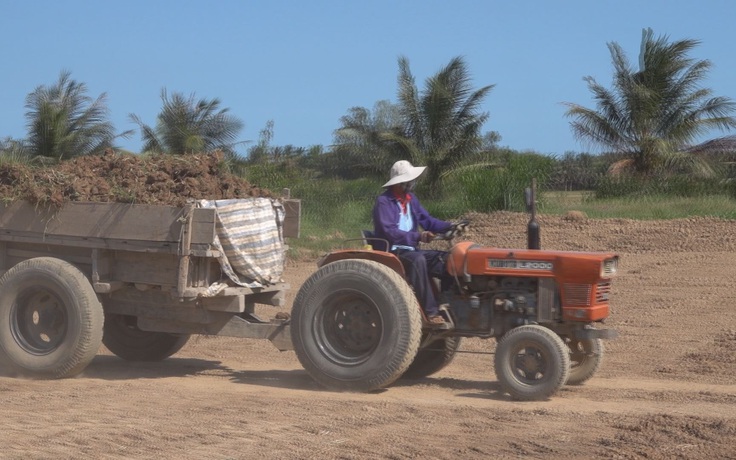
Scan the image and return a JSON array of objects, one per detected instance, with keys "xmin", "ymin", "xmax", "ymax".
[{"xmin": 0, "ymin": 201, "xmax": 290, "ymax": 297}]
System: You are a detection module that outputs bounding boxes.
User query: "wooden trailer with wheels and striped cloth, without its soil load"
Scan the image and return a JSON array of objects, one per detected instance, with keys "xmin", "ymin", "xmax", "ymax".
[{"xmin": 0, "ymin": 198, "xmax": 300, "ymax": 378}]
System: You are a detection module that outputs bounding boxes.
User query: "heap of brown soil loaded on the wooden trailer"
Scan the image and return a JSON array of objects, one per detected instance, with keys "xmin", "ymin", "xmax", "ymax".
[{"xmin": 0, "ymin": 149, "xmax": 272, "ymax": 206}]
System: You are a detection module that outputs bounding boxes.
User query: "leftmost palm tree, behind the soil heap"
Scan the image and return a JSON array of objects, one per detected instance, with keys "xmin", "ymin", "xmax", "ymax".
[{"xmin": 26, "ymin": 71, "xmax": 129, "ymax": 160}]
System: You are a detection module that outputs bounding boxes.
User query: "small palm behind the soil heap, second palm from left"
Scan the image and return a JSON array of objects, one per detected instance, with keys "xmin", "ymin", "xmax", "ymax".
[{"xmin": 130, "ymin": 89, "xmax": 243, "ymax": 155}]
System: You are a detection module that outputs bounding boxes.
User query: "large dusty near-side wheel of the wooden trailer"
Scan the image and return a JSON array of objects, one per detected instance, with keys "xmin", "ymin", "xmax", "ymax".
[{"xmin": 0, "ymin": 257, "xmax": 104, "ymax": 378}]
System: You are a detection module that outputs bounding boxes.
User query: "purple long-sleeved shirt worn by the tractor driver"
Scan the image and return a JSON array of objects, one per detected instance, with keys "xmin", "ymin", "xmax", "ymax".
[{"xmin": 373, "ymin": 188, "xmax": 452, "ymax": 248}]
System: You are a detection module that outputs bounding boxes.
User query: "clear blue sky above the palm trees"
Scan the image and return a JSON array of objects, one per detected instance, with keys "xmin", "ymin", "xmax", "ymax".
[{"xmin": 0, "ymin": 0, "xmax": 736, "ymax": 155}]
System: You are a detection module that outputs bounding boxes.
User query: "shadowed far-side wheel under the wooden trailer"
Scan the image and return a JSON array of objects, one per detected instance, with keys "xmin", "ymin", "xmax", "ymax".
[{"xmin": 102, "ymin": 313, "xmax": 189, "ymax": 361}]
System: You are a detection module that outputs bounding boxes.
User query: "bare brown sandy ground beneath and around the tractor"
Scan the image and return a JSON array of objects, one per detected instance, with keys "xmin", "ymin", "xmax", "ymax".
[{"xmin": 0, "ymin": 213, "xmax": 736, "ymax": 459}]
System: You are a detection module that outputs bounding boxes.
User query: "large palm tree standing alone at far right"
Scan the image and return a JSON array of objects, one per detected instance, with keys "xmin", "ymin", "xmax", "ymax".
[{"xmin": 565, "ymin": 29, "xmax": 736, "ymax": 176}]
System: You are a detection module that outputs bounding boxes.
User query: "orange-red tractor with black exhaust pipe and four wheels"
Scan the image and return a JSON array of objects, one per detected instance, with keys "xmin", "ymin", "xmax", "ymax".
[{"xmin": 291, "ymin": 185, "xmax": 618, "ymax": 400}]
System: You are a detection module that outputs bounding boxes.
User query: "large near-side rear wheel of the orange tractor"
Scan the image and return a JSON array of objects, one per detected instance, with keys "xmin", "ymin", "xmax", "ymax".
[{"xmin": 291, "ymin": 259, "xmax": 422, "ymax": 391}]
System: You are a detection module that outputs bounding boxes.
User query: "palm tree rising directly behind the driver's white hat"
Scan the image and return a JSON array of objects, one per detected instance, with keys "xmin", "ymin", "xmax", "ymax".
[{"xmin": 333, "ymin": 57, "xmax": 499, "ymax": 193}]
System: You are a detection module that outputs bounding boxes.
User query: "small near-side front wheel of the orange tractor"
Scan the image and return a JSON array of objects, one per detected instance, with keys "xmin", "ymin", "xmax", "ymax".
[{"xmin": 494, "ymin": 325, "xmax": 570, "ymax": 401}]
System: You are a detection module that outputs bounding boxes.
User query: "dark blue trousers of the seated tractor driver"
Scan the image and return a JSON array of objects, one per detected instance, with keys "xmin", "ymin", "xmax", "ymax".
[{"xmin": 394, "ymin": 249, "xmax": 452, "ymax": 317}]
